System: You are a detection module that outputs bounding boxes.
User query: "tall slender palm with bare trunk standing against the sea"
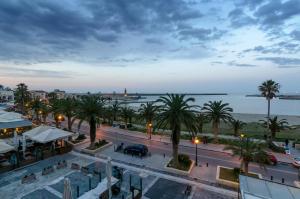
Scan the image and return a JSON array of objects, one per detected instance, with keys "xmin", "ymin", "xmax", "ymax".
[{"xmin": 258, "ymin": 79, "xmax": 280, "ymax": 118}]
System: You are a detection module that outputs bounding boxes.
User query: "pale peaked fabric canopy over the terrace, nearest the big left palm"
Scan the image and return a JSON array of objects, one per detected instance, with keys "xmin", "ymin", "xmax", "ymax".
[{"xmin": 23, "ymin": 125, "xmax": 73, "ymax": 143}]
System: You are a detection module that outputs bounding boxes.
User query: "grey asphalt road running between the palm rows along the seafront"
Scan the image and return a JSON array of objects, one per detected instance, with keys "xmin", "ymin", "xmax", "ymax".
[{"xmin": 58, "ymin": 119, "xmax": 298, "ymax": 187}]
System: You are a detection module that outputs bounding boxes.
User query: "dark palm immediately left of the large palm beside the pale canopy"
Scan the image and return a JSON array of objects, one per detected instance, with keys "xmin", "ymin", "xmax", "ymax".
[{"xmin": 59, "ymin": 97, "xmax": 78, "ymax": 131}]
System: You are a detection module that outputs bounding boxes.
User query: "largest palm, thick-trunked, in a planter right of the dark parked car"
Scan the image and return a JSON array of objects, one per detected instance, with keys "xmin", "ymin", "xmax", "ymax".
[{"xmin": 157, "ymin": 94, "xmax": 198, "ymax": 167}]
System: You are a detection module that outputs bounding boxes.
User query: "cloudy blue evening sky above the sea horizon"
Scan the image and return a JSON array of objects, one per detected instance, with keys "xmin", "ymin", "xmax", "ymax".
[{"xmin": 0, "ymin": 0, "xmax": 300, "ymax": 93}]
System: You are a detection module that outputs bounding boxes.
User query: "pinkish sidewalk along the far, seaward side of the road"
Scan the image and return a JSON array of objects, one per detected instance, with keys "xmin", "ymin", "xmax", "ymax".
[{"xmin": 100, "ymin": 126, "xmax": 294, "ymax": 164}]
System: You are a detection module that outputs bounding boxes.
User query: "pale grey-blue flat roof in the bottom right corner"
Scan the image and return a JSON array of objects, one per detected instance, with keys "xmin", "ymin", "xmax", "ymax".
[{"xmin": 239, "ymin": 175, "xmax": 300, "ymax": 199}]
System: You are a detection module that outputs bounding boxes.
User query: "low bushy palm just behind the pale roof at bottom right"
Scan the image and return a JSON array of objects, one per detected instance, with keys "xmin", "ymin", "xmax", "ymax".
[{"xmin": 224, "ymin": 138, "xmax": 270, "ymax": 174}]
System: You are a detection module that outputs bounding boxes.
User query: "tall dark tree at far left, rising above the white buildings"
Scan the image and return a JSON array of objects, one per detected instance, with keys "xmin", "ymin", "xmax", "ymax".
[{"xmin": 15, "ymin": 83, "xmax": 30, "ymax": 114}]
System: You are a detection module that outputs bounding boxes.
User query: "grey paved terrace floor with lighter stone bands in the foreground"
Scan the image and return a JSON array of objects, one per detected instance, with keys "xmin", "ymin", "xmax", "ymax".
[{"xmin": 0, "ymin": 152, "xmax": 235, "ymax": 199}]
